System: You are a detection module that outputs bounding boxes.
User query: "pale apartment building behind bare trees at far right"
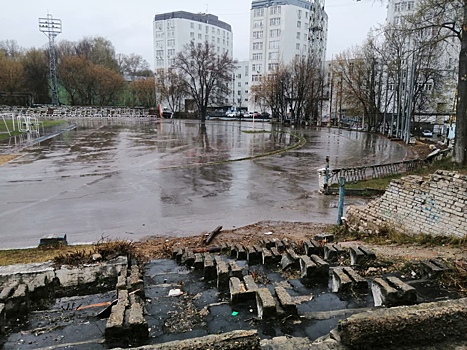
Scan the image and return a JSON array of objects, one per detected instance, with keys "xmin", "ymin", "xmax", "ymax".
[{"xmin": 387, "ymin": 0, "xmax": 460, "ymax": 135}]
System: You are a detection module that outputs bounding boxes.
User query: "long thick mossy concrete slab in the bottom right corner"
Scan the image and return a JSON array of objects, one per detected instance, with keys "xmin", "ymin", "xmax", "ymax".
[{"xmin": 338, "ymin": 298, "xmax": 467, "ymax": 350}]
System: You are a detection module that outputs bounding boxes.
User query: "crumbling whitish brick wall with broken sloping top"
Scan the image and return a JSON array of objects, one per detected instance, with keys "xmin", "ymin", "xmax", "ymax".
[{"xmin": 346, "ymin": 170, "xmax": 467, "ymax": 238}]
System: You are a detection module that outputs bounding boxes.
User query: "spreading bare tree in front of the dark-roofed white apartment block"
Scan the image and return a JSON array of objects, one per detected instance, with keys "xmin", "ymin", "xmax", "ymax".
[{"xmin": 173, "ymin": 42, "xmax": 237, "ymax": 121}]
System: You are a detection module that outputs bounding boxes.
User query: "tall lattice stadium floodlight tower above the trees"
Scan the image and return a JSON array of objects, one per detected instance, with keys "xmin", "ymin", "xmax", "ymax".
[{"xmin": 39, "ymin": 14, "xmax": 62, "ymax": 106}]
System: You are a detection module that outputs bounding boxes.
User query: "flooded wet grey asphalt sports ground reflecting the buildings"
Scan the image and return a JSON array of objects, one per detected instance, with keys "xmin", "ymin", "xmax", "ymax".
[{"xmin": 0, "ymin": 118, "xmax": 413, "ymax": 248}]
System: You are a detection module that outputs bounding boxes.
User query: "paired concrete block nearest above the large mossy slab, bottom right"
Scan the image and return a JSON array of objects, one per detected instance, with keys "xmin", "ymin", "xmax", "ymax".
[{"xmin": 371, "ymin": 276, "xmax": 417, "ymax": 307}]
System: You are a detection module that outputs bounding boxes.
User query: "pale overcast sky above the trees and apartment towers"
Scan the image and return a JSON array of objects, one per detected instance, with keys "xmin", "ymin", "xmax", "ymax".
[{"xmin": 0, "ymin": 0, "xmax": 387, "ymax": 67}]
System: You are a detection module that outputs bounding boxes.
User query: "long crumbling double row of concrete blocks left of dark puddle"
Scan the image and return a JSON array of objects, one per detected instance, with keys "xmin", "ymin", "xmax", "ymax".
[{"xmin": 104, "ymin": 264, "xmax": 149, "ymax": 346}]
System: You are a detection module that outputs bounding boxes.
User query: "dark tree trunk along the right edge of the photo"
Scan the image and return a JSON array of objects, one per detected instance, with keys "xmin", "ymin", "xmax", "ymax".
[{"xmin": 454, "ymin": 0, "xmax": 467, "ymax": 164}]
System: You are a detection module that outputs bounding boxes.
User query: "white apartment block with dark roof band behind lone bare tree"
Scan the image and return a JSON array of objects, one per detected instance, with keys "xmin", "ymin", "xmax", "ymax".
[{"xmin": 153, "ymin": 11, "xmax": 233, "ymax": 72}]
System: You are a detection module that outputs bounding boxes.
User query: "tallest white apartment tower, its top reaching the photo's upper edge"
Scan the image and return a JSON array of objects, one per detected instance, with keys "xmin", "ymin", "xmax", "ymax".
[{"xmin": 249, "ymin": 0, "xmax": 328, "ymax": 109}]
